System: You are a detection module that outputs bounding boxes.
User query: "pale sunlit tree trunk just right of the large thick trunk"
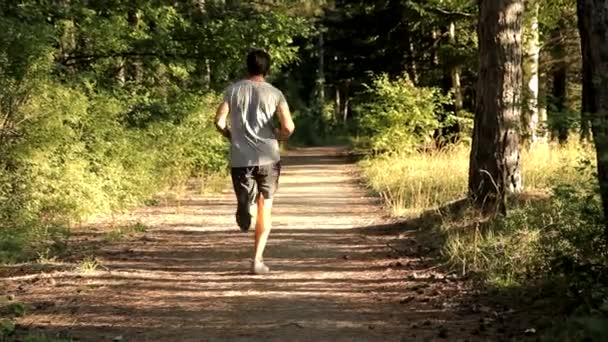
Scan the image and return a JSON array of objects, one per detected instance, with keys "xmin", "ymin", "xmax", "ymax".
[{"xmin": 522, "ymin": 1, "xmax": 546, "ymax": 144}]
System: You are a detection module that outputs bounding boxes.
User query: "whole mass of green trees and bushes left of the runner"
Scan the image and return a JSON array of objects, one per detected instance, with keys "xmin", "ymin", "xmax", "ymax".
[{"xmin": 0, "ymin": 0, "xmax": 310, "ymax": 262}]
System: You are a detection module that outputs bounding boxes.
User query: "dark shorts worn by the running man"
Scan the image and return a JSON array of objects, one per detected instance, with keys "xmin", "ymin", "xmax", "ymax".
[{"xmin": 231, "ymin": 162, "xmax": 281, "ymax": 211}]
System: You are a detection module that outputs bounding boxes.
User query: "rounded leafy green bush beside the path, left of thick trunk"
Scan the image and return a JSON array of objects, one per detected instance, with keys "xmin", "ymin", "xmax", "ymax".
[{"xmin": 355, "ymin": 75, "xmax": 451, "ymax": 152}]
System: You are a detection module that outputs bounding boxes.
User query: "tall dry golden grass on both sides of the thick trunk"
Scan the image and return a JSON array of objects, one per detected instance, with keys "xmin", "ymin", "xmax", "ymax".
[{"xmin": 362, "ymin": 143, "xmax": 593, "ymax": 217}]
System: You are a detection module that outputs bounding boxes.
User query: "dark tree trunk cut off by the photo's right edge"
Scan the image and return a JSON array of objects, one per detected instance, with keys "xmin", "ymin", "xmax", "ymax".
[{"xmin": 578, "ymin": 0, "xmax": 608, "ymax": 242}]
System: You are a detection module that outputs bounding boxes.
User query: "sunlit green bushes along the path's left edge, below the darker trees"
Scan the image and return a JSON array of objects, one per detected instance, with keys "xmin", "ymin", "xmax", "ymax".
[{"xmin": 0, "ymin": 81, "xmax": 227, "ymax": 261}]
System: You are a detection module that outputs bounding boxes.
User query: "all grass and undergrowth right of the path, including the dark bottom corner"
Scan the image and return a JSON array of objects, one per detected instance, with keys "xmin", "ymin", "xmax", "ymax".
[{"xmin": 362, "ymin": 143, "xmax": 608, "ymax": 341}]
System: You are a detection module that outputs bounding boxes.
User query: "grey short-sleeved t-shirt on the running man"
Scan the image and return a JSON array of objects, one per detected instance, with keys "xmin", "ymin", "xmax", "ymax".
[{"xmin": 224, "ymin": 80, "xmax": 285, "ymax": 167}]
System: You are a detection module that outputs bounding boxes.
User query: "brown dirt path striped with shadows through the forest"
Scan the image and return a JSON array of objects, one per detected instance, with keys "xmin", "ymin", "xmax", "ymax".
[{"xmin": 4, "ymin": 149, "xmax": 498, "ymax": 341}]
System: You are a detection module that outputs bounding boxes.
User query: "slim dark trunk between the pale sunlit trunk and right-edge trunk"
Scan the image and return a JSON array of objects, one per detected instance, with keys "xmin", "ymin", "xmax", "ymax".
[{"xmin": 551, "ymin": 25, "xmax": 570, "ymax": 144}]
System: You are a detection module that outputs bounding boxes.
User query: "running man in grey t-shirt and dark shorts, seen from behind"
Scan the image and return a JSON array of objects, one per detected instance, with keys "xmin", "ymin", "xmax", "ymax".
[{"xmin": 215, "ymin": 50, "xmax": 295, "ymax": 274}]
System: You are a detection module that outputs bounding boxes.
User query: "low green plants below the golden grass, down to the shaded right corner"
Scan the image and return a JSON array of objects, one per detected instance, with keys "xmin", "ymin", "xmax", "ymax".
[{"xmin": 444, "ymin": 162, "xmax": 608, "ymax": 341}]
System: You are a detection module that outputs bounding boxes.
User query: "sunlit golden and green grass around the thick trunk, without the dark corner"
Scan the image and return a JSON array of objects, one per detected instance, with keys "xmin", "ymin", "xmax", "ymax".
[{"xmin": 362, "ymin": 138, "xmax": 605, "ymax": 287}]
